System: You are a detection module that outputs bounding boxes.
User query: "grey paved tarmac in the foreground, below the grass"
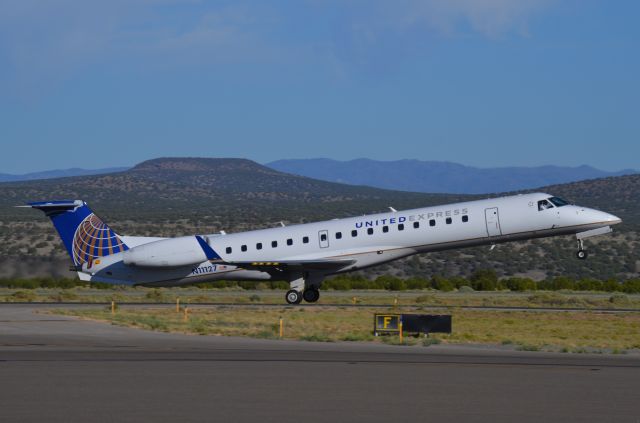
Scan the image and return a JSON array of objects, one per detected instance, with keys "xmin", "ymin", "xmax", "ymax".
[{"xmin": 0, "ymin": 305, "xmax": 640, "ymax": 423}]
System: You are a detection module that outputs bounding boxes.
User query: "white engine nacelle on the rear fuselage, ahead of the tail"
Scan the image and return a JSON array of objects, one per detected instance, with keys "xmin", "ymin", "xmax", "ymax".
[{"xmin": 122, "ymin": 236, "xmax": 213, "ymax": 267}]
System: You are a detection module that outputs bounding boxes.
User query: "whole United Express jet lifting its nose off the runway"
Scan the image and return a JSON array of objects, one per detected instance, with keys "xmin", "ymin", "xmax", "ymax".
[{"xmin": 23, "ymin": 193, "xmax": 622, "ymax": 304}]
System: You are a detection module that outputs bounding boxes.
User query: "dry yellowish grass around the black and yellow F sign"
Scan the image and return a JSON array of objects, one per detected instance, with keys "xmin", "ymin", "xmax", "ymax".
[{"xmin": 55, "ymin": 306, "xmax": 640, "ymax": 353}]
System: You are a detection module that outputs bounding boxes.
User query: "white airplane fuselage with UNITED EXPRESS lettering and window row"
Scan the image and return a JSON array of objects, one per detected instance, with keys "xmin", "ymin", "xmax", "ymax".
[{"xmin": 80, "ymin": 193, "xmax": 620, "ymax": 285}]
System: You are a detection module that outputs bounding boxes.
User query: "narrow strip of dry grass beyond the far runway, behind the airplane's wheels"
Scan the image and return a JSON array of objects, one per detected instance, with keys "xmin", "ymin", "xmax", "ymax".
[{"xmin": 7, "ymin": 287, "xmax": 640, "ymax": 311}]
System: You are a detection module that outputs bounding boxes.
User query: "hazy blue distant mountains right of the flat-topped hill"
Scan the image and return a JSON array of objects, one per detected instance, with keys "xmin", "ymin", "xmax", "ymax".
[{"xmin": 267, "ymin": 159, "xmax": 638, "ymax": 194}]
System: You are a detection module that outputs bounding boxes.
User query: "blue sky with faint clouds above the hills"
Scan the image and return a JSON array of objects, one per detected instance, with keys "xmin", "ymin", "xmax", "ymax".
[{"xmin": 0, "ymin": 0, "xmax": 640, "ymax": 173}]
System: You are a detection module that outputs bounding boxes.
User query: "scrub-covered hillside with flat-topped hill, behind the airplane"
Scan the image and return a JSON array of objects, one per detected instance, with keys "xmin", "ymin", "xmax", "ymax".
[{"xmin": 0, "ymin": 158, "xmax": 640, "ymax": 279}]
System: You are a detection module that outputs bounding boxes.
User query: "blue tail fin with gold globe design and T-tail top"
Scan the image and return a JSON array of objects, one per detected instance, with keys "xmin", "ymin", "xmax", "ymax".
[{"xmin": 19, "ymin": 200, "xmax": 129, "ymax": 266}]
